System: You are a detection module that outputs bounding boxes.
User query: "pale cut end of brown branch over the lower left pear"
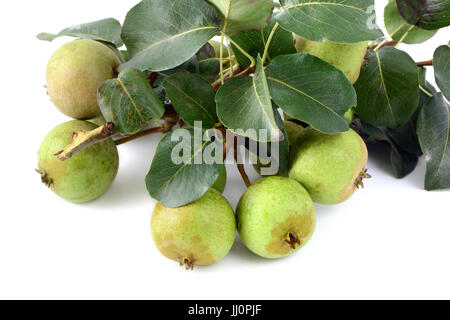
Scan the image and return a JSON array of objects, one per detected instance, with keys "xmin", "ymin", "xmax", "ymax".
[{"xmin": 55, "ymin": 122, "xmax": 116, "ymax": 161}]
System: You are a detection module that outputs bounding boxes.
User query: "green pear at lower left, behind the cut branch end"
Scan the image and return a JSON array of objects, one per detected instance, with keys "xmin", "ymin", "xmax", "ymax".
[{"xmin": 38, "ymin": 120, "xmax": 119, "ymax": 203}]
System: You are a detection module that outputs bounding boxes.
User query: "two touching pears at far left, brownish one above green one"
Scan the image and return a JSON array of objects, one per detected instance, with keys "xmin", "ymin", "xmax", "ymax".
[{"xmin": 37, "ymin": 40, "xmax": 119, "ymax": 203}]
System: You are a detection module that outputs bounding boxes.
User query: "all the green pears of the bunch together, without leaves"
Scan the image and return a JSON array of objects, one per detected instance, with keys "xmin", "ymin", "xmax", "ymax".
[{"xmin": 38, "ymin": 36, "xmax": 368, "ymax": 269}]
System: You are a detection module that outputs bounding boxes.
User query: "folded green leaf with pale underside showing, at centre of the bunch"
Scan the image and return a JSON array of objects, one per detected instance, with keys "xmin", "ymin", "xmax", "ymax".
[{"xmin": 216, "ymin": 57, "xmax": 280, "ymax": 142}]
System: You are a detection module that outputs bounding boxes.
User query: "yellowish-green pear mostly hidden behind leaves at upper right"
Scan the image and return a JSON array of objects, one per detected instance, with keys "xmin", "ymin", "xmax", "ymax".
[{"xmin": 295, "ymin": 35, "xmax": 368, "ymax": 84}]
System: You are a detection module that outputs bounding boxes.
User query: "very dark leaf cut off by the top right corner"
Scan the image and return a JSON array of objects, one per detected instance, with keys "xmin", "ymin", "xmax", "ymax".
[{"xmin": 396, "ymin": 0, "xmax": 450, "ymax": 30}]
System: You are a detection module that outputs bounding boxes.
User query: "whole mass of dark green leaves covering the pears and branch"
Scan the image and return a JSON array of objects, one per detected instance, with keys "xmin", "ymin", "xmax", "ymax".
[{"xmin": 38, "ymin": 0, "xmax": 450, "ymax": 207}]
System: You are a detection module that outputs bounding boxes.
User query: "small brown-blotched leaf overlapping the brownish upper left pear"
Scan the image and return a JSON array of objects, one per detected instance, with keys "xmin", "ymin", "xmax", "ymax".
[{"xmin": 98, "ymin": 69, "xmax": 164, "ymax": 134}]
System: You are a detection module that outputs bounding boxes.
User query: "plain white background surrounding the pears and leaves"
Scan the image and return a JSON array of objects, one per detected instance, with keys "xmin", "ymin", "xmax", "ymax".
[{"xmin": 0, "ymin": 0, "xmax": 450, "ymax": 299}]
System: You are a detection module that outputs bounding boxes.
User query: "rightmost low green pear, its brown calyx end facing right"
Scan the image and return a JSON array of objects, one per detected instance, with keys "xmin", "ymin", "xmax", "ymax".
[{"xmin": 289, "ymin": 128, "xmax": 368, "ymax": 204}]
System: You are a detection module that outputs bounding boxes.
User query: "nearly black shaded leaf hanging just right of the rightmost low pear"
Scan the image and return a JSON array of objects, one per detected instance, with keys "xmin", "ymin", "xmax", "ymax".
[{"xmin": 354, "ymin": 119, "xmax": 419, "ymax": 179}]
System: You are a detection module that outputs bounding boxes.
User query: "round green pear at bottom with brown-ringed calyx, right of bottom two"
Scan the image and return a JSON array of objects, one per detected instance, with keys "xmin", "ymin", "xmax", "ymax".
[{"xmin": 236, "ymin": 176, "xmax": 316, "ymax": 259}]
